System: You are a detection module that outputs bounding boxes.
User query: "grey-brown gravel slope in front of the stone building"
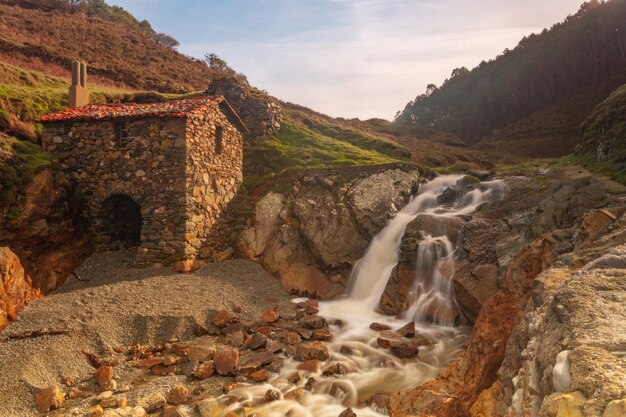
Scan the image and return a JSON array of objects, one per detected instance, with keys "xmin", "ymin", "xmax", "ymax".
[{"xmin": 0, "ymin": 252, "xmax": 291, "ymax": 417}]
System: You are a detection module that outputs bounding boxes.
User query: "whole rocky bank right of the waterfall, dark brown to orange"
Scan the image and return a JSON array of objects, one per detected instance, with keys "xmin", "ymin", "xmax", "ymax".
[{"xmin": 391, "ymin": 168, "xmax": 626, "ymax": 417}]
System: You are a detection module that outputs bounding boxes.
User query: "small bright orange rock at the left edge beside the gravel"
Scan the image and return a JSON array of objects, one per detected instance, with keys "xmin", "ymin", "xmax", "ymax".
[{"xmin": 0, "ymin": 247, "xmax": 40, "ymax": 330}]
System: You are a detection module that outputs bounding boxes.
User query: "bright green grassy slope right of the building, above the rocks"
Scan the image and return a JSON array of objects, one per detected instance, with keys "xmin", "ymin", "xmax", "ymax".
[{"xmin": 245, "ymin": 118, "xmax": 406, "ymax": 184}]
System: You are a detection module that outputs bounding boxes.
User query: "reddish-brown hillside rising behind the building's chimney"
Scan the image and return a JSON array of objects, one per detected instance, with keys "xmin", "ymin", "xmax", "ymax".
[{"xmin": 0, "ymin": 0, "xmax": 211, "ymax": 93}]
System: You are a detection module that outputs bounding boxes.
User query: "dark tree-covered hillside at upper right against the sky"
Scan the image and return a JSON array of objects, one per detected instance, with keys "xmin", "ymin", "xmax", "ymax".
[{"xmin": 397, "ymin": 0, "xmax": 626, "ymax": 144}]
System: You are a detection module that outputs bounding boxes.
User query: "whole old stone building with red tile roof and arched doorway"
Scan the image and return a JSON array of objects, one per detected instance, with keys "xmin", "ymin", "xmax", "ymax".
[{"xmin": 40, "ymin": 94, "xmax": 246, "ymax": 270}]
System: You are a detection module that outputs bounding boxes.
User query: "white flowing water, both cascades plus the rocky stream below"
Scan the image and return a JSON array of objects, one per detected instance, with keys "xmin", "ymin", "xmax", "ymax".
[{"xmin": 202, "ymin": 175, "xmax": 505, "ymax": 417}]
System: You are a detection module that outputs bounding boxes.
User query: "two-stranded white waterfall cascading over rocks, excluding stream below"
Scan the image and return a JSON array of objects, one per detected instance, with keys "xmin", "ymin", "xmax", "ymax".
[{"xmin": 348, "ymin": 175, "xmax": 504, "ymax": 325}]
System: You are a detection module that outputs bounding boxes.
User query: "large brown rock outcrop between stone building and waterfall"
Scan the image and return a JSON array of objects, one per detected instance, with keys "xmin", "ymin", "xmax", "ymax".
[{"xmin": 238, "ymin": 169, "xmax": 420, "ymax": 298}]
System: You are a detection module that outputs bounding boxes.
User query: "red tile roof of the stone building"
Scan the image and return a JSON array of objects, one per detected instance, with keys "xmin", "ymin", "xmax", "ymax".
[{"xmin": 37, "ymin": 96, "xmax": 224, "ymax": 123}]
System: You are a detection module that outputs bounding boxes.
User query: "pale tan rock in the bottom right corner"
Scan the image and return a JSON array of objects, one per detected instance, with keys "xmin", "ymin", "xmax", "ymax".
[{"xmin": 471, "ymin": 246, "xmax": 626, "ymax": 417}]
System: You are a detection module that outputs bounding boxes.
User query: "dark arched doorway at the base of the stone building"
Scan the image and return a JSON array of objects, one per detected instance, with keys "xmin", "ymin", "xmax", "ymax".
[{"xmin": 100, "ymin": 194, "xmax": 143, "ymax": 246}]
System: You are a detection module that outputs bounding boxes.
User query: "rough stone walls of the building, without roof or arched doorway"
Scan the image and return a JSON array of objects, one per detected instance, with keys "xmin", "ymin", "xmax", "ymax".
[{"xmin": 43, "ymin": 107, "xmax": 243, "ymax": 270}]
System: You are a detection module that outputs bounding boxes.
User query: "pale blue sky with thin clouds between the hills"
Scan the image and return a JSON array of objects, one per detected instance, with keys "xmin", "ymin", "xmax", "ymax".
[{"xmin": 107, "ymin": 0, "xmax": 583, "ymax": 119}]
